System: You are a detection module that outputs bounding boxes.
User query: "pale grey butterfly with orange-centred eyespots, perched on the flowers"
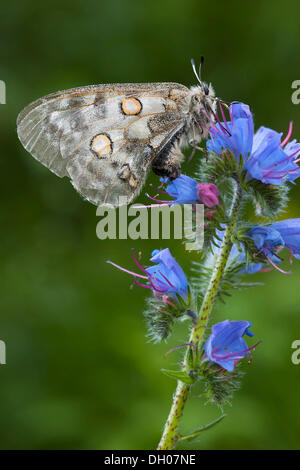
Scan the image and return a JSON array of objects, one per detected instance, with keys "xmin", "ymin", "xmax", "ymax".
[{"xmin": 17, "ymin": 61, "xmax": 216, "ymax": 207}]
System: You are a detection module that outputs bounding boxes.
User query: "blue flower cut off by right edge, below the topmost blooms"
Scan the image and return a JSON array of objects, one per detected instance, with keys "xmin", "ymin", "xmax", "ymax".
[{"xmin": 247, "ymin": 219, "xmax": 300, "ymax": 273}]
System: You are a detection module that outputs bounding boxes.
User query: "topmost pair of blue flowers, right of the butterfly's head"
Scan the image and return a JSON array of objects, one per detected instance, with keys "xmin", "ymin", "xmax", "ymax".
[{"xmin": 206, "ymin": 103, "xmax": 300, "ymax": 185}]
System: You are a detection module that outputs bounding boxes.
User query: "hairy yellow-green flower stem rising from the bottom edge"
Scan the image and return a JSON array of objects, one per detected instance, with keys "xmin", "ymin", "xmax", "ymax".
[{"xmin": 158, "ymin": 181, "xmax": 241, "ymax": 450}]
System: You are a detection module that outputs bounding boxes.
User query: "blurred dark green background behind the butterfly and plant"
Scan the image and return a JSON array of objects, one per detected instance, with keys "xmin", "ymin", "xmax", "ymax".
[{"xmin": 0, "ymin": 0, "xmax": 300, "ymax": 449}]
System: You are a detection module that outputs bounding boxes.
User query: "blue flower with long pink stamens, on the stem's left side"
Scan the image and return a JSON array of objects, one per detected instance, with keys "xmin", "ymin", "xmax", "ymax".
[{"xmin": 107, "ymin": 248, "xmax": 188, "ymax": 305}]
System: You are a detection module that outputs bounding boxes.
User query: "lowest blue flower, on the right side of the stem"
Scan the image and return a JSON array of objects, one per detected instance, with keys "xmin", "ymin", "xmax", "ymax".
[{"xmin": 204, "ymin": 320, "xmax": 261, "ymax": 372}]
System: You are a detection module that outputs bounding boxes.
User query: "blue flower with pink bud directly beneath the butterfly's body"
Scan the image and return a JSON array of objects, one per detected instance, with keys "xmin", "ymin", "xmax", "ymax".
[{"xmin": 147, "ymin": 174, "xmax": 219, "ymax": 208}]
